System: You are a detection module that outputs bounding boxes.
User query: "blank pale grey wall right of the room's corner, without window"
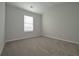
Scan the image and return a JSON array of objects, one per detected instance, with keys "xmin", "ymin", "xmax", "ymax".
[{"xmin": 43, "ymin": 5, "xmax": 79, "ymax": 43}]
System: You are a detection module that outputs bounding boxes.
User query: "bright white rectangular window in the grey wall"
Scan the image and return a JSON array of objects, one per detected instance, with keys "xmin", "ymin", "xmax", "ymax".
[{"xmin": 24, "ymin": 15, "xmax": 33, "ymax": 32}]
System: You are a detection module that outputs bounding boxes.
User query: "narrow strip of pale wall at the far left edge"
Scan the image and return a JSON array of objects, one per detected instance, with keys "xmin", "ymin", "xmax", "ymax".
[{"xmin": 0, "ymin": 2, "xmax": 5, "ymax": 55}]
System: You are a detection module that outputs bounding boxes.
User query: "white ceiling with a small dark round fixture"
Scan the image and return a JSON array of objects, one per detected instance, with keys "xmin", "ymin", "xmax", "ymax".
[{"xmin": 7, "ymin": 2, "xmax": 79, "ymax": 14}]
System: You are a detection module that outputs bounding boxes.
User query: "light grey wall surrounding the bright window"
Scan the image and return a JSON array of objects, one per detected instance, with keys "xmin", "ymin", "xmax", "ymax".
[{"xmin": 6, "ymin": 5, "xmax": 41, "ymax": 41}]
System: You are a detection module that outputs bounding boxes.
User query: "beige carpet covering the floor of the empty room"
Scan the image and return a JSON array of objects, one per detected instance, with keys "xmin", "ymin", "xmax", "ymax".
[{"xmin": 2, "ymin": 37, "xmax": 79, "ymax": 56}]
